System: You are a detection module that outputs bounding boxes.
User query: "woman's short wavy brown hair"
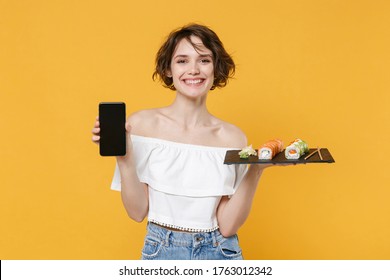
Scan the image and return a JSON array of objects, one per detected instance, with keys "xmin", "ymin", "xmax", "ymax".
[{"xmin": 153, "ymin": 24, "xmax": 235, "ymax": 90}]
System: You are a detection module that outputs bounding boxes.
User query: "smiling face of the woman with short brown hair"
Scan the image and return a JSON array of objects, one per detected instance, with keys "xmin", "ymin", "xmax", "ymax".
[{"xmin": 168, "ymin": 36, "xmax": 214, "ymax": 98}]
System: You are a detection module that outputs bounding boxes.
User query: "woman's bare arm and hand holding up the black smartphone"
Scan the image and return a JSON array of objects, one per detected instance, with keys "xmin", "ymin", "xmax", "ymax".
[{"xmin": 92, "ymin": 117, "xmax": 149, "ymax": 222}]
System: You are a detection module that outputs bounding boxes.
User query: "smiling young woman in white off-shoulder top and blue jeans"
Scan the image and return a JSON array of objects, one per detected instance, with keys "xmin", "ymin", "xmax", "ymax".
[{"xmin": 92, "ymin": 24, "xmax": 272, "ymax": 260}]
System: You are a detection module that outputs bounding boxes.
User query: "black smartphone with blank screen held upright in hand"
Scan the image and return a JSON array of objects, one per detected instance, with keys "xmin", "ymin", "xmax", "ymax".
[{"xmin": 99, "ymin": 102, "xmax": 126, "ymax": 156}]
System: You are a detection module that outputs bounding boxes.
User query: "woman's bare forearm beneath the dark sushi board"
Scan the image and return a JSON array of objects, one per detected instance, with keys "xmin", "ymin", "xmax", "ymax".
[{"xmin": 217, "ymin": 165, "xmax": 264, "ymax": 236}]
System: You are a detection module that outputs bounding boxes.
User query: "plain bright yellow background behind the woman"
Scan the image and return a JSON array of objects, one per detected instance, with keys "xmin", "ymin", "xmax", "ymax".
[{"xmin": 0, "ymin": 0, "xmax": 390, "ymax": 259}]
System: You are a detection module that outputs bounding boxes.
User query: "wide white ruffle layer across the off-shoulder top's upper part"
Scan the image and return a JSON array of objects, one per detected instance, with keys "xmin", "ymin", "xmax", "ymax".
[{"xmin": 111, "ymin": 135, "xmax": 247, "ymax": 197}]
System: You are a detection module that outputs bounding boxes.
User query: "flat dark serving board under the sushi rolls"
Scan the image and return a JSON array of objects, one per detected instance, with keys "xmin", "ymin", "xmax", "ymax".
[{"xmin": 224, "ymin": 148, "xmax": 335, "ymax": 164}]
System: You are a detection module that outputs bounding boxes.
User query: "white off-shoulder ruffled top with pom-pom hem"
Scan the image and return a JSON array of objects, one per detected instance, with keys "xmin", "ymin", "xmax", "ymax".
[{"xmin": 111, "ymin": 135, "xmax": 247, "ymax": 232}]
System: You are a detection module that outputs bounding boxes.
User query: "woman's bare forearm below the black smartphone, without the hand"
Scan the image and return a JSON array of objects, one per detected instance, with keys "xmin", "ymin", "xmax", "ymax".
[{"xmin": 118, "ymin": 158, "xmax": 149, "ymax": 222}]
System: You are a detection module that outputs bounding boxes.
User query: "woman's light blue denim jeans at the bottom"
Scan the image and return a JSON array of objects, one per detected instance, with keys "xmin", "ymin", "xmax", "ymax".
[{"xmin": 142, "ymin": 223, "xmax": 243, "ymax": 260}]
